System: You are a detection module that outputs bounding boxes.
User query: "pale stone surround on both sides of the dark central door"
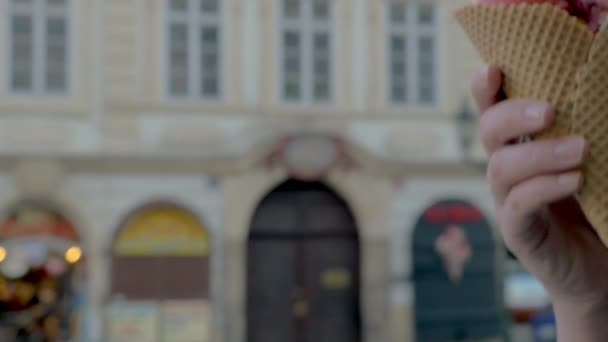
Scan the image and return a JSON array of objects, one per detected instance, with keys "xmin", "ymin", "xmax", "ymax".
[{"xmin": 223, "ymin": 168, "xmax": 392, "ymax": 342}]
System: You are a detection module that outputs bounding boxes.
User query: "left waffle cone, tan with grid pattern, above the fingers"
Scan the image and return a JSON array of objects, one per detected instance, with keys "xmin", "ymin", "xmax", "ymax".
[{"xmin": 456, "ymin": 4, "xmax": 594, "ymax": 138}]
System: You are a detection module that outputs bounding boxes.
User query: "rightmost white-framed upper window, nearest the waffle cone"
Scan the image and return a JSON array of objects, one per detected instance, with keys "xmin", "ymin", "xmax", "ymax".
[{"xmin": 388, "ymin": 0, "xmax": 437, "ymax": 105}]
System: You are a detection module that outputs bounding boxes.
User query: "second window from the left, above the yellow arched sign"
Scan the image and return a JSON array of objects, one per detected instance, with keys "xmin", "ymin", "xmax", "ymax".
[{"xmin": 167, "ymin": 0, "xmax": 221, "ymax": 98}]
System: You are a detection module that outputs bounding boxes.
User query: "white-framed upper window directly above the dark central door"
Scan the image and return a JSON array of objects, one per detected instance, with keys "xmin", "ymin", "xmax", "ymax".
[{"xmin": 281, "ymin": 0, "xmax": 333, "ymax": 103}]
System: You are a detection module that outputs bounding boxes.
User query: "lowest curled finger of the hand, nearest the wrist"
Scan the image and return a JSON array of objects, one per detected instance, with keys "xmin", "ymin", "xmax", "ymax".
[{"xmin": 501, "ymin": 171, "xmax": 582, "ymax": 249}]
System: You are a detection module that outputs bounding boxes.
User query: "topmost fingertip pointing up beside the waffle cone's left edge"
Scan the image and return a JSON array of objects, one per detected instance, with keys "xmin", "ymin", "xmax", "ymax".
[{"xmin": 471, "ymin": 65, "xmax": 502, "ymax": 113}]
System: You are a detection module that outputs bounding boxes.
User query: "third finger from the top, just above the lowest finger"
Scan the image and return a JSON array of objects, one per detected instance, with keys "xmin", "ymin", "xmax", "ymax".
[{"xmin": 487, "ymin": 137, "xmax": 588, "ymax": 204}]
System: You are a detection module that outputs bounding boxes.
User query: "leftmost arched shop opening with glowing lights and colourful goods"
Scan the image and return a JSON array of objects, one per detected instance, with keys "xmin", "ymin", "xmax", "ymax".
[{"xmin": 0, "ymin": 200, "xmax": 86, "ymax": 342}]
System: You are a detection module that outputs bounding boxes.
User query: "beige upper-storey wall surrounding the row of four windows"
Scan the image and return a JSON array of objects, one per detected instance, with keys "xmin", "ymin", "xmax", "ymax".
[{"xmin": 0, "ymin": 0, "xmax": 490, "ymax": 153}]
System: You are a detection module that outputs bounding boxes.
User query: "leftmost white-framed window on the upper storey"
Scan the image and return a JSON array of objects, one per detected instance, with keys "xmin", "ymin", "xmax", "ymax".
[{"xmin": 7, "ymin": 0, "xmax": 69, "ymax": 95}]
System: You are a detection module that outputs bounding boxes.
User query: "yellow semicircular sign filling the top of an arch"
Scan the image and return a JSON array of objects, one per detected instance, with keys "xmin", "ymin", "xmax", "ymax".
[{"xmin": 114, "ymin": 205, "xmax": 210, "ymax": 256}]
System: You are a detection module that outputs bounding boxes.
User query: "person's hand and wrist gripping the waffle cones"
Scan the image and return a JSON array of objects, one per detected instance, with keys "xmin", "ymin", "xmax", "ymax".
[{"xmin": 472, "ymin": 66, "xmax": 608, "ymax": 342}]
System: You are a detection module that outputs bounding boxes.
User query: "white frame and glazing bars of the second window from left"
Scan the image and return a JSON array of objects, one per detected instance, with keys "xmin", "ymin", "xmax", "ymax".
[{"xmin": 159, "ymin": 0, "xmax": 229, "ymax": 104}]
